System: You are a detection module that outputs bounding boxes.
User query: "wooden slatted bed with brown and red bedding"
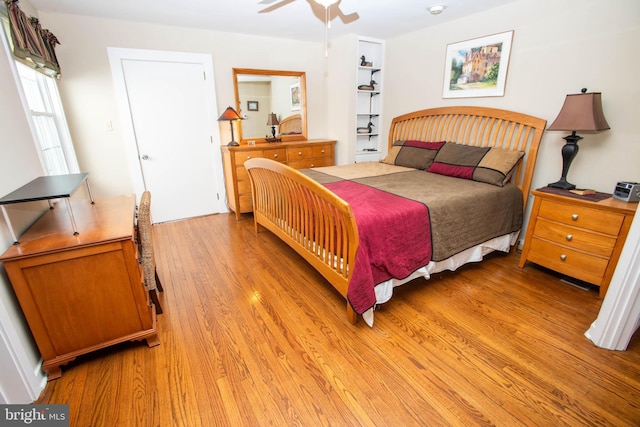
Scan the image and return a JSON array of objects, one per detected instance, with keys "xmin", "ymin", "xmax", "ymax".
[{"xmin": 245, "ymin": 107, "xmax": 546, "ymax": 326}]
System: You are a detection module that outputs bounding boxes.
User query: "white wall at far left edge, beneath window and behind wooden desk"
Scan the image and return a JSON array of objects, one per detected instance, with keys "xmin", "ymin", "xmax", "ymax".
[{"xmin": 0, "ymin": 0, "xmax": 46, "ymax": 403}]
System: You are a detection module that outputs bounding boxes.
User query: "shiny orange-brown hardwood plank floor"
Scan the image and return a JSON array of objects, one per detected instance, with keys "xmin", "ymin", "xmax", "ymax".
[{"xmin": 38, "ymin": 214, "xmax": 640, "ymax": 427}]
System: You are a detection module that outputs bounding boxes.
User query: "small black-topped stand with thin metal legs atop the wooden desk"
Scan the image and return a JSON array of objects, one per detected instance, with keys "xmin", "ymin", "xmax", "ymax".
[{"xmin": 0, "ymin": 172, "xmax": 93, "ymax": 244}]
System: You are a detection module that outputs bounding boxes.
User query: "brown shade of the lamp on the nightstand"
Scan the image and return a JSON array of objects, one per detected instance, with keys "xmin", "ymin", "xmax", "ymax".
[{"xmin": 547, "ymin": 92, "xmax": 610, "ymax": 132}]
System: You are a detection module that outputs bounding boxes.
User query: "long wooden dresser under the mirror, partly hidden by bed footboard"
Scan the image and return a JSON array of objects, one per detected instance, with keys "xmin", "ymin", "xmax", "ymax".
[{"xmin": 222, "ymin": 139, "xmax": 336, "ymax": 219}]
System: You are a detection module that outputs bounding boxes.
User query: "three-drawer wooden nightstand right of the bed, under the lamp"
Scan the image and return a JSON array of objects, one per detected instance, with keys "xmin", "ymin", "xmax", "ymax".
[{"xmin": 520, "ymin": 187, "xmax": 638, "ymax": 298}]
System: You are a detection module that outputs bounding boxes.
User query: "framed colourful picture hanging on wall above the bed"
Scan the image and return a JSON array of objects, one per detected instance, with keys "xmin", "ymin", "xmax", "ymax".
[{"xmin": 442, "ymin": 31, "xmax": 513, "ymax": 98}]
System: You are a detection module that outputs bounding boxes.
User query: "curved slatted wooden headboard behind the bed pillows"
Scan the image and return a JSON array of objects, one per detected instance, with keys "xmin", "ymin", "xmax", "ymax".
[{"xmin": 389, "ymin": 106, "xmax": 547, "ymax": 207}]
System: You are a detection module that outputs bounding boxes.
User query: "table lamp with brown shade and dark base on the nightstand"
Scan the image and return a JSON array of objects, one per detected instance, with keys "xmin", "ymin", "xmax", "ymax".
[{"xmin": 547, "ymin": 88, "xmax": 610, "ymax": 190}]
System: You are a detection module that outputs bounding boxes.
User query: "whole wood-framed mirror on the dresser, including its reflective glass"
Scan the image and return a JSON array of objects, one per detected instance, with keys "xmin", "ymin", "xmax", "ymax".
[{"xmin": 233, "ymin": 68, "xmax": 307, "ymax": 143}]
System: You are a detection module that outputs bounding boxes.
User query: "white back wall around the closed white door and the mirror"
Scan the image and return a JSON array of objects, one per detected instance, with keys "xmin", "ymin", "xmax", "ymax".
[{"xmin": 35, "ymin": 12, "xmax": 326, "ymax": 197}]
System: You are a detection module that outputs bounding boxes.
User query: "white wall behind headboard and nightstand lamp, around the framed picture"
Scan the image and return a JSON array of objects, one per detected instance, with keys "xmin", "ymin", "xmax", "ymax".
[{"xmin": 383, "ymin": 0, "xmax": 640, "ymax": 202}]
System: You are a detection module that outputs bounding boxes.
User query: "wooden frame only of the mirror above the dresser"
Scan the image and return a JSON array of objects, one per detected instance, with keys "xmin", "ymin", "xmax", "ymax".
[{"xmin": 233, "ymin": 68, "xmax": 307, "ymax": 144}]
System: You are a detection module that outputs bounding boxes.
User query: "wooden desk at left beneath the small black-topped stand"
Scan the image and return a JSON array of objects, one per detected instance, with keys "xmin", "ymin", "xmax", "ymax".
[{"xmin": 0, "ymin": 196, "xmax": 160, "ymax": 380}]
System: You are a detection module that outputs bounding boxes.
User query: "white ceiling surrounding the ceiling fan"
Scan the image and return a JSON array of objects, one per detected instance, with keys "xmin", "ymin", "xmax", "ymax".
[{"xmin": 28, "ymin": 0, "xmax": 516, "ymax": 42}]
